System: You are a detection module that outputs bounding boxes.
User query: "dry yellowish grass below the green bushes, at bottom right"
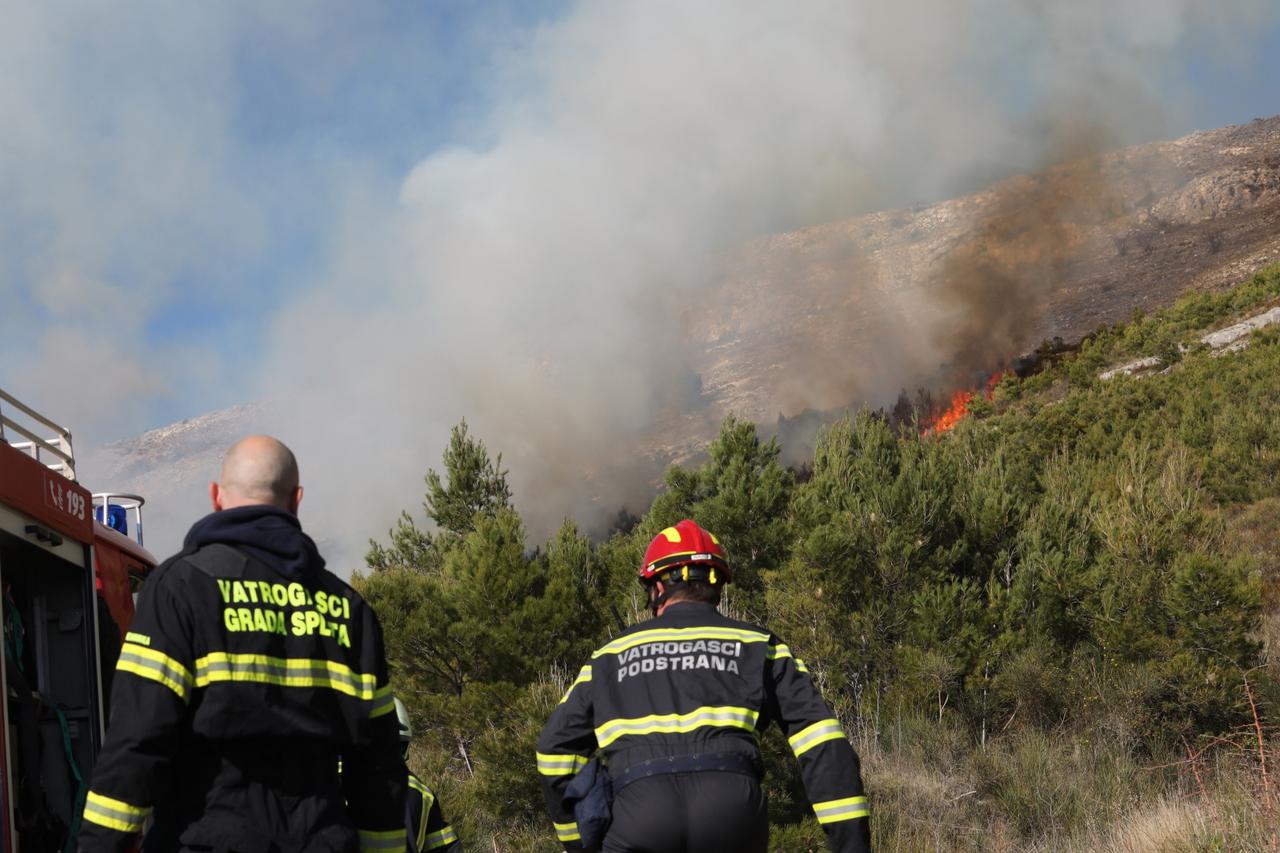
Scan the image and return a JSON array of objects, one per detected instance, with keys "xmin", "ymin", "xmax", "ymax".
[{"xmin": 844, "ymin": 722, "xmax": 1280, "ymax": 853}]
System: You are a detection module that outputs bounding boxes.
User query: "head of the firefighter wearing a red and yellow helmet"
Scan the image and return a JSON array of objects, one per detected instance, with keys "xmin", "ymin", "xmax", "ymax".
[{"xmin": 640, "ymin": 519, "xmax": 732, "ymax": 613}]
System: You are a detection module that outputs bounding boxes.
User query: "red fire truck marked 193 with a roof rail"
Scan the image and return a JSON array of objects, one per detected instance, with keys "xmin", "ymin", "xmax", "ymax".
[{"xmin": 0, "ymin": 391, "xmax": 156, "ymax": 853}]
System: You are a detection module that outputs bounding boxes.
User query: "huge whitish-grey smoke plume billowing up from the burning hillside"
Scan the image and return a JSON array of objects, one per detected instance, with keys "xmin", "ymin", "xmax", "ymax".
[{"xmin": 259, "ymin": 0, "xmax": 1275, "ymax": 568}]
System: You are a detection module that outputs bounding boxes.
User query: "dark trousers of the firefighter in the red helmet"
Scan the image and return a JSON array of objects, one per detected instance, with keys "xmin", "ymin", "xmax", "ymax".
[{"xmin": 603, "ymin": 771, "xmax": 769, "ymax": 853}]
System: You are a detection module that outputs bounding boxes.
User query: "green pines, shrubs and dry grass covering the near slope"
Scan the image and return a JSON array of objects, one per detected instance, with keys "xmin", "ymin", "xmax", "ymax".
[{"xmin": 356, "ymin": 266, "xmax": 1280, "ymax": 852}]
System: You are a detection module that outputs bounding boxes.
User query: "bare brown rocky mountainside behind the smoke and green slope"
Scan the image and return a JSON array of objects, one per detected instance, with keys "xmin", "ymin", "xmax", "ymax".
[{"xmin": 94, "ymin": 118, "xmax": 1280, "ymax": 547}]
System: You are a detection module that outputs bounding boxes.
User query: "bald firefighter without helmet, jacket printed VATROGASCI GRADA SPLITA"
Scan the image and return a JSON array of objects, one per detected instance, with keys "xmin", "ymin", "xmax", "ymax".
[{"xmin": 78, "ymin": 435, "xmax": 408, "ymax": 853}]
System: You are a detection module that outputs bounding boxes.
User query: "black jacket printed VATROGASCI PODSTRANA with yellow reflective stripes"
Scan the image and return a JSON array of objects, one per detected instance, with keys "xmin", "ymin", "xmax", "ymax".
[{"xmin": 536, "ymin": 602, "xmax": 870, "ymax": 853}]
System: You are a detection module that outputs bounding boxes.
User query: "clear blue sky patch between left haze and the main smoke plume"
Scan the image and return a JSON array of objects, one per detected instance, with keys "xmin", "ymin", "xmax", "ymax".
[{"xmin": 136, "ymin": 0, "xmax": 564, "ymax": 423}]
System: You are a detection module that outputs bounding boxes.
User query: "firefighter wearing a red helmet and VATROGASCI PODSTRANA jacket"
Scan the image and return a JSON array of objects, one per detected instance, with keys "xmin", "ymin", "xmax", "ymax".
[{"xmin": 536, "ymin": 520, "xmax": 870, "ymax": 853}]
